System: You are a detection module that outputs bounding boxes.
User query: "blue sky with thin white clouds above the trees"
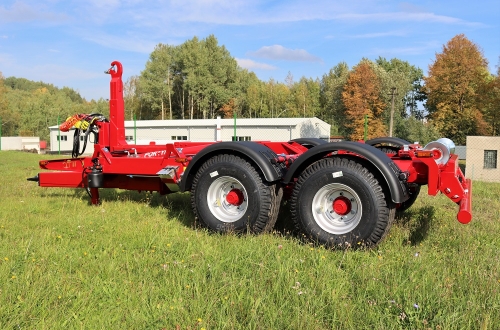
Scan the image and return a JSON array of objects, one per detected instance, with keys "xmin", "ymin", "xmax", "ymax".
[{"xmin": 0, "ymin": 0, "xmax": 500, "ymax": 100}]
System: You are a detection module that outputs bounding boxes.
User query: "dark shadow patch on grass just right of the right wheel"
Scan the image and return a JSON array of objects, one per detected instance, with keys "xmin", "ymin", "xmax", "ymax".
[{"xmin": 396, "ymin": 206, "xmax": 435, "ymax": 246}]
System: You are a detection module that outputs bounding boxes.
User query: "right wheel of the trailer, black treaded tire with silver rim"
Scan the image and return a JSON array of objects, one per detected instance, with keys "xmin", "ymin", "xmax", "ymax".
[{"xmin": 290, "ymin": 157, "xmax": 395, "ymax": 248}]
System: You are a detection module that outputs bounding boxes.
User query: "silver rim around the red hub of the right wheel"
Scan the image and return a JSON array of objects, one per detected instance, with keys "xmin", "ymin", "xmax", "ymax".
[{"xmin": 312, "ymin": 183, "xmax": 363, "ymax": 235}]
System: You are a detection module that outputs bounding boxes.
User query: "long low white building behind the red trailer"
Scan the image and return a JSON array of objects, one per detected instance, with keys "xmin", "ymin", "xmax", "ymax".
[{"xmin": 49, "ymin": 117, "xmax": 330, "ymax": 154}]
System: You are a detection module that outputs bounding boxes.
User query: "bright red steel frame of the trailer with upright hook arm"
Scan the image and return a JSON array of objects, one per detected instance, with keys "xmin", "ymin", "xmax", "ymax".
[{"xmin": 38, "ymin": 61, "xmax": 472, "ymax": 223}]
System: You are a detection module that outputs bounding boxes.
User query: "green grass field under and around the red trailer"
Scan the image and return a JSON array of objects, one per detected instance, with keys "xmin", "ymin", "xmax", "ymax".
[{"xmin": 0, "ymin": 151, "xmax": 500, "ymax": 329}]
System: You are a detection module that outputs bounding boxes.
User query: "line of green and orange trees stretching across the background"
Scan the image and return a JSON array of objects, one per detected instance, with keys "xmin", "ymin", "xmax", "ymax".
[{"xmin": 0, "ymin": 35, "xmax": 500, "ymax": 145}]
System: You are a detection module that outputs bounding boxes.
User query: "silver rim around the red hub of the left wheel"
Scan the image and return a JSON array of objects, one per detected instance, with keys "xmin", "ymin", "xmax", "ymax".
[{"xmin": 207, "ymin": 176, "xmax": 248, "ymax": 222}]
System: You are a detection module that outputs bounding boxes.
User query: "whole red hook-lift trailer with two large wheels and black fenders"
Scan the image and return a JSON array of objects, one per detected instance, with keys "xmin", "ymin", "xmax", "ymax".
[{"xmin": 28, "ymin": 61, "xmax": 472, "ymax": 247}]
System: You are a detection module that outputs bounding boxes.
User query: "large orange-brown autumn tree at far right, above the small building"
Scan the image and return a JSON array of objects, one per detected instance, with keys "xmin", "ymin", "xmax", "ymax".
[{"xmin": 424, "ymin": 34, "xmax": 490, "ymax": 145}]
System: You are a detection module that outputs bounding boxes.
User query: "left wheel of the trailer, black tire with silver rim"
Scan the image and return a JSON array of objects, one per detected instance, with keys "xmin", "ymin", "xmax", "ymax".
[{"xmin": 191, "ymin": 154, "xmax": 283, "ymax": 233}]
